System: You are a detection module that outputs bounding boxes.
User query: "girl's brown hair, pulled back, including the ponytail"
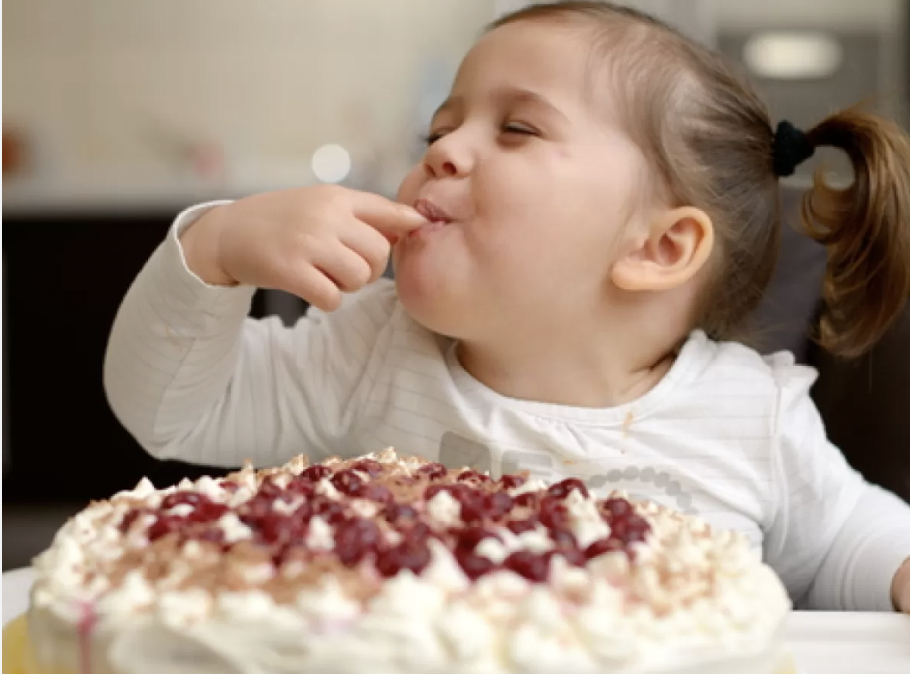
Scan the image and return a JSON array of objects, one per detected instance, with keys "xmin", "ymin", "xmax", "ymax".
[{"xmin": 490, "ymin": 1, "xmax": 910, "ymax": 356}]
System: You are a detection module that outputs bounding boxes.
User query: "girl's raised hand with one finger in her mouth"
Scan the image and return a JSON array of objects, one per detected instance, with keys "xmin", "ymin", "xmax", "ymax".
[{"xmin": 181, "ymin": 185, "xmax": 427, "ymax": 311}]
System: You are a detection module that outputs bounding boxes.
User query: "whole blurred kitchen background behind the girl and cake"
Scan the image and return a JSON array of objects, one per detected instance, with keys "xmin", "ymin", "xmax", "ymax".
[{"xmin": 3, "ymin": 0, "xmax": 910, "ymax": 569}]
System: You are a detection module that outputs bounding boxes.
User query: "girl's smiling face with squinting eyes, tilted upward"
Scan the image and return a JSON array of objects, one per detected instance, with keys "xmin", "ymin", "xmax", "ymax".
[{"xmin": 393, "ymin": 22, "xmax": 647, "ymax": 342}]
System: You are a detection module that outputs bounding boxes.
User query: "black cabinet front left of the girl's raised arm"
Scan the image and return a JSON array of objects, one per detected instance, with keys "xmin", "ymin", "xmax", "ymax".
[{"xmin": 3, "ymin": 206, "xmax": 280, "ymax": 506}]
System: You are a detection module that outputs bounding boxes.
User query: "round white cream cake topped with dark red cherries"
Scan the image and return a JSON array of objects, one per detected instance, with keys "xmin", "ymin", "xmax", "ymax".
[{"xmin": 3, "ymin": 449, "xmax": 792, "ymax": 674}]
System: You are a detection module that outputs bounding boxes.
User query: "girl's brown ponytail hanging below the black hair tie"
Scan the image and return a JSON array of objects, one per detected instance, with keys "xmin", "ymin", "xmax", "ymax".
[{"xmin": 802, "ymin": 109, "xmax": 910, "ymax": 357}]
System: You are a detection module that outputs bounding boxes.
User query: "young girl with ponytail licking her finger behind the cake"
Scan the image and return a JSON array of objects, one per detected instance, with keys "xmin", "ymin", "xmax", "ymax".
[{"xmin": 105, "ymin": 2, "xmax": 910, "ymax": 611}]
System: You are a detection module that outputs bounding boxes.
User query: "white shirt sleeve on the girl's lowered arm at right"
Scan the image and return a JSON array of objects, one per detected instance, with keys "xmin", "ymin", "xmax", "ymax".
[{"xmin": 765, "ymin": 366, "xmax": 910, "ymax": 611}]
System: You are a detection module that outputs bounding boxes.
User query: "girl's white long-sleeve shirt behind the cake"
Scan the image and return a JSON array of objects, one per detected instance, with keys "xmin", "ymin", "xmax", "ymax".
[{"xmin": 104, "ymin": 205, "xmax": 910, "ymax": 611}]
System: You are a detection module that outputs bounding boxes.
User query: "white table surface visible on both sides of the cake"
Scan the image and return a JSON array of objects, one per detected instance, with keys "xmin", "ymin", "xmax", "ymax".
[{"xmin": 2, "ymin": 569, "xmax": 910, "ymax": 674}]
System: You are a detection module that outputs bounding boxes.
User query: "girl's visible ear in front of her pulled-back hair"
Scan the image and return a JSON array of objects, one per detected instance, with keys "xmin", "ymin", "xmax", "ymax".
[{"xmin": 611, "ymin": 206, "xmax": 714, "ymax": 292}]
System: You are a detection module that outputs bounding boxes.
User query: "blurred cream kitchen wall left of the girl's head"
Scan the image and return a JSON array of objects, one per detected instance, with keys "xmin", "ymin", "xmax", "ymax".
[{"xmin": 3, "ymin": 0, "xmax": 492, "ymax": 189}]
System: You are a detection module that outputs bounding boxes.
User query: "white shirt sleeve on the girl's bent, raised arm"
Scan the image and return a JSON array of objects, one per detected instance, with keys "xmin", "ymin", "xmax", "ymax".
[{"xmin": 104, "ymin": 203, "xmax": 395, "ymax": 467}]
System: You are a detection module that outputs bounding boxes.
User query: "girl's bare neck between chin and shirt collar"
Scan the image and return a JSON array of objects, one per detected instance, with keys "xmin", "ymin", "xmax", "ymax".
[{"xmin": 458, "ymin": 308, "xmax": 680, "ymax": 408}]
